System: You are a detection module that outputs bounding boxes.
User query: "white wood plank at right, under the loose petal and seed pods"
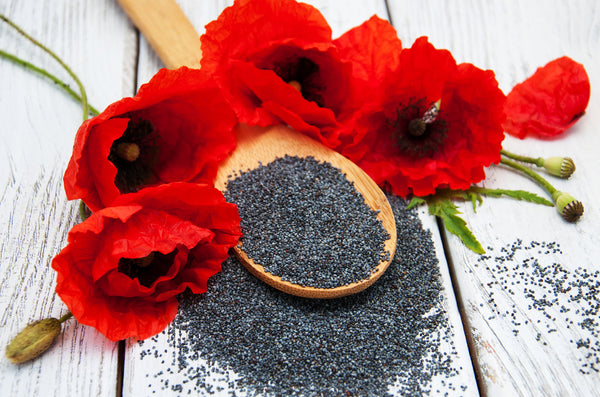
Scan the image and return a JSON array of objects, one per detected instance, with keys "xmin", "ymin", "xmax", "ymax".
[{"xmin": 390, "ymin": 1, "xmax": 600, "ymax": 396}]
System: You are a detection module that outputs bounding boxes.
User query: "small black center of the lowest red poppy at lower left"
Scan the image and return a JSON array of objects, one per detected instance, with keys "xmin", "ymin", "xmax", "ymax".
[{"xmin": 118, "ymin": 250, "xmax": 177, "ymax": 287}]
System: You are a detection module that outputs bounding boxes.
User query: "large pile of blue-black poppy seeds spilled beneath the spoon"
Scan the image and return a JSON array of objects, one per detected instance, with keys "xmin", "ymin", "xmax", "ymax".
[{"xmin": 140, "ymin": 192, "xmax": 466, "ymax": 396}]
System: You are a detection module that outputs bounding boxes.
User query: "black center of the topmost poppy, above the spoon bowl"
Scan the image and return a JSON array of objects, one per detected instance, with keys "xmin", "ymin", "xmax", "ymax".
[{"xmin": 273, "ymin": 57, "xmax": 324, "ymax": 107}]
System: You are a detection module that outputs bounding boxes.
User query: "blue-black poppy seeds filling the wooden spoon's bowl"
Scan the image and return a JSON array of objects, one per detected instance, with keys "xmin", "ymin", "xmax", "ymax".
[{"xmin": 225, "ymin": 156, "xmax": 390, "ymax": 288}]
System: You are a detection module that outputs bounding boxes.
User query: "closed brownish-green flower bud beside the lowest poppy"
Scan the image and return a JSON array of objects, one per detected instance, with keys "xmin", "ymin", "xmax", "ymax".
[{"xmin": 6, "ymin": 318, "xmax": 60, "ymax": 364}]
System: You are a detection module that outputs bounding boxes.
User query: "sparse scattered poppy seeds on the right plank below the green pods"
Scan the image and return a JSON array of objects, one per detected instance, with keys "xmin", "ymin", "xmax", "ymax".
[{"xmin": 475, "ymin": 239, "xmax": 600, "ymax": 376}]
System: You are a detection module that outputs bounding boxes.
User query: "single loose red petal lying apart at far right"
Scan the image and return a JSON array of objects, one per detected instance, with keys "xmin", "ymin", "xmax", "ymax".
[{"xmin": 504, "ymin": 57, "xmax": 590, "ymax": 139}]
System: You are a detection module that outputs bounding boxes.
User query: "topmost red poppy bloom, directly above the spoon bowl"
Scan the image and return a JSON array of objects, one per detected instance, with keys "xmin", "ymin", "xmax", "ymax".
[{"xmin": 200, "ymin": 0, "xmax": 351, "ymax": 145}]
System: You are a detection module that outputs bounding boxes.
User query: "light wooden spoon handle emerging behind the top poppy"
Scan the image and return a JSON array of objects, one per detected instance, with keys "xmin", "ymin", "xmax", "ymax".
[{"xmin": 118, "ymin": 0, "xmax": 202, "ymax": 69}]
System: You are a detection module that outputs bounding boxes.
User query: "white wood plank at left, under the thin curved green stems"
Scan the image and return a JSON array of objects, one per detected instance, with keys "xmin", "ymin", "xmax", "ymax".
[{"xmin": 0, "ymin": 0, "xmax": 136, "ymax": 396}]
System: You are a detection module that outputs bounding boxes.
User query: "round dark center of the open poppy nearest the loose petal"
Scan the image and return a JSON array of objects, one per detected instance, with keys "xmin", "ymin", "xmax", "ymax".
[{"xmin": 388, "ymin": 98, "xmax": 448, "ymax": 157}]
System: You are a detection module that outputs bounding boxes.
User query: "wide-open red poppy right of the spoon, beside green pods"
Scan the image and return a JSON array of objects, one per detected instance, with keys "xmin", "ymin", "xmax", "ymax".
[{"xmin": 339, "ymin": 37, "xmax": 505, "ymax": 196}]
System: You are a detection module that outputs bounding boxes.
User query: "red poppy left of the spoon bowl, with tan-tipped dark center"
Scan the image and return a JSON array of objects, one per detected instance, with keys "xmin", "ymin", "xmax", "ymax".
[{"xmin": 64, "ymin": 67, "xmax": 237, "ymax": 211}]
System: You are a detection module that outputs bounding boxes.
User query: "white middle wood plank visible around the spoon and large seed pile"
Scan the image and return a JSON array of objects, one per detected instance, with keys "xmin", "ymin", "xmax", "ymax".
[{"xmin": 123, "ymin": 0, "xmax": 478, "ymax": 396}]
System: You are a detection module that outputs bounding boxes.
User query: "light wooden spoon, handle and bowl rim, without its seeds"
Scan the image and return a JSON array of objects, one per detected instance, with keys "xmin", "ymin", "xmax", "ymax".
[{"xmin": 118, "ymin": 0, "xmax": 396, "ymax": 298}]
